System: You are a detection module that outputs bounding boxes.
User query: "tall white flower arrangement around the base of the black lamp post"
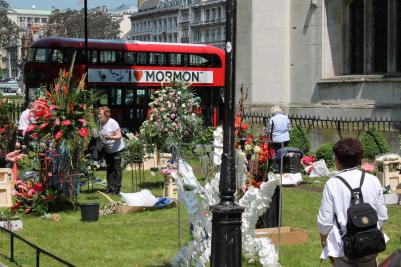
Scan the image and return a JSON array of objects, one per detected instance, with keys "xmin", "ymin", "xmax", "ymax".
[{"xmin": 171, "ymin": 127, "xmax": 279, "ymax": 267}]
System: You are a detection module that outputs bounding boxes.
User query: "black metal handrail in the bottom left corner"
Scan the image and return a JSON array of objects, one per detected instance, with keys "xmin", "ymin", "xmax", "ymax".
[{"xmin": 0, "ymin": 226, "xmax": 74, "ymax": 267}]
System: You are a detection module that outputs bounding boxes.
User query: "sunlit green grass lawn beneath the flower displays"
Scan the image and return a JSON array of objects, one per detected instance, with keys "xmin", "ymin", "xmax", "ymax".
[{"xmin": 0, "ymin": 171, "xmax": 401, "ymax": 267}]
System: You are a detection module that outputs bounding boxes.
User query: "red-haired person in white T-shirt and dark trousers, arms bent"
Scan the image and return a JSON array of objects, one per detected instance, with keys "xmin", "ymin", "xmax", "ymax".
[{"xmin": 98, "ymin": 107, "xmax": 125, "ymax": 194}]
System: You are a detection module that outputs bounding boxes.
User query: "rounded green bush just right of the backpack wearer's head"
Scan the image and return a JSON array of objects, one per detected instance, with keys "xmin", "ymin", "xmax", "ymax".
[{"xmin": 361, "ymin": 128, "xmax": 390, "ymax": 160}]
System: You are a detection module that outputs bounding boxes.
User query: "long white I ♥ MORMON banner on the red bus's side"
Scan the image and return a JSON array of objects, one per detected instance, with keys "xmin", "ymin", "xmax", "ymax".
[{"xmin": 88, "ymin": 69, "xmax": 213, "ymax": 83}]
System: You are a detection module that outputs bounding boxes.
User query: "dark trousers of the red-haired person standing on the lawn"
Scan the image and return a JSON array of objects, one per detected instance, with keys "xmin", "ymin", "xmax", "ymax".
[{"xmin": 105, "ymin": 151, "xmax": 123, "ymax": 193}]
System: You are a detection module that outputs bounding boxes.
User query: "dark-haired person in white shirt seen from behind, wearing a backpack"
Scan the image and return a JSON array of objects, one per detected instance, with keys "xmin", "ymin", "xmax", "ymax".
[{"xmin": 317, "ymin": 138, "xmax": 388, "ymax": 267}]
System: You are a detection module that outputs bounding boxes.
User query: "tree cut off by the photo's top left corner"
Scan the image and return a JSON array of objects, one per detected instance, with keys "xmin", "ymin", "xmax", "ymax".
[{"xmin": 0, "ymin": 0, "xmax": 18, "ymax": 46}]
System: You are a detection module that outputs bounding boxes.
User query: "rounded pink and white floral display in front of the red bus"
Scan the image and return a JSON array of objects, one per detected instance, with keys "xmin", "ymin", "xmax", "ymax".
[{"xmin": 141, "ymin": 82, "xmax": 202, "ymax": 154}]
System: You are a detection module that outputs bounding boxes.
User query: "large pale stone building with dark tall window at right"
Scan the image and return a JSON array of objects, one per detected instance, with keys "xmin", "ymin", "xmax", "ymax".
[{"xmin": 236, "ymin": 0, "xmax": 401, "ymax": 120}]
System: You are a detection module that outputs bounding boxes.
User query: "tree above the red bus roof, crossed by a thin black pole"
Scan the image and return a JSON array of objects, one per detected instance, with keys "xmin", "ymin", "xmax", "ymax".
[{"xmin": 45, "ymin": 7, "xmax": 120, "ymax": 39}]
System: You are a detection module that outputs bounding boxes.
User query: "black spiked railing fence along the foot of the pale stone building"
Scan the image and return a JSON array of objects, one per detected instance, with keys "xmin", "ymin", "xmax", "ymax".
[{"xmin": 244, "ymin": 112, "xmax": 401, "ymax": 134}]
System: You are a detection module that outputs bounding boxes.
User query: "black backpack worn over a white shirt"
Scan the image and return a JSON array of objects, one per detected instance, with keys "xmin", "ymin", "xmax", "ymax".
[{"xmin": 334, "ymin": 170, "xmax": 386, "ymax": 259}]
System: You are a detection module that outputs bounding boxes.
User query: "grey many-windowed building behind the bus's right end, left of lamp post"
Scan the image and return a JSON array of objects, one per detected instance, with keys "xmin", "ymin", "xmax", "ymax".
[{"xmin": 128, "ymin": 0, "xmax": 225, "ymax": 48}]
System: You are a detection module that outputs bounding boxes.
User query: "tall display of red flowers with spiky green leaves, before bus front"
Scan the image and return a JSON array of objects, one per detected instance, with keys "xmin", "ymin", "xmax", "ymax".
[{"xmin": 27, "ymin": 70, "xmax": 94, "ymax": 147}]
